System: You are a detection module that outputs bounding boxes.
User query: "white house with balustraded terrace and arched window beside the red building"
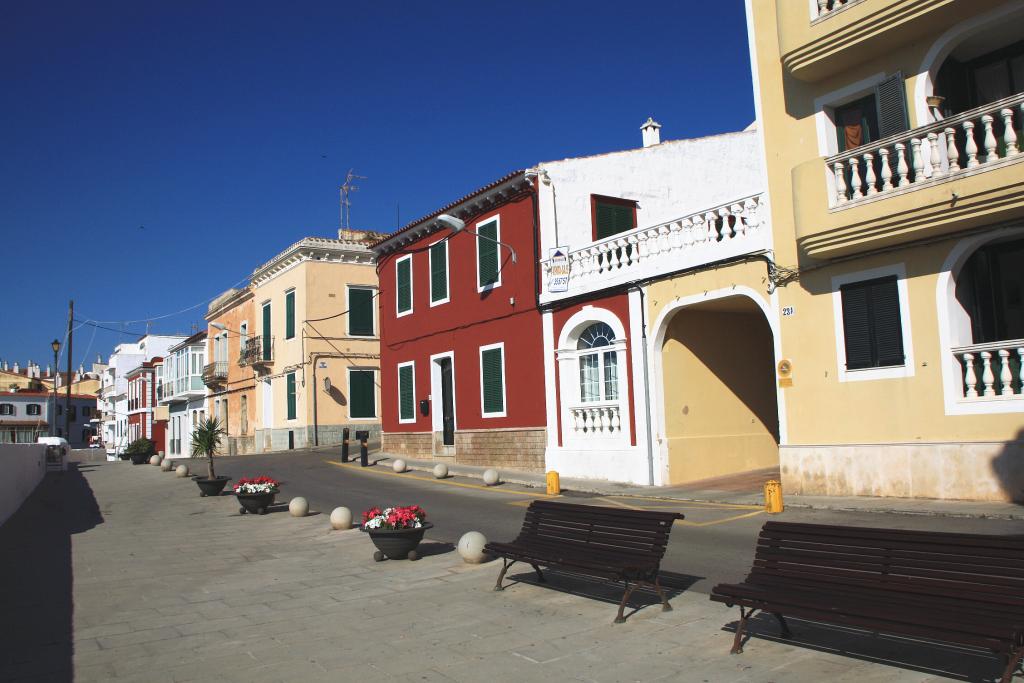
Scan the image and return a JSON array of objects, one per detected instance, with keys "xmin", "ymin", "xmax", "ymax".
[{"xmin": 530, "ymin": 119, "xmax": 771, "ymax": 484}]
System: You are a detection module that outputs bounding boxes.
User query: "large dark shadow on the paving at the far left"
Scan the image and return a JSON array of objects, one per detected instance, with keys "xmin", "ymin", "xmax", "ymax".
[{"xmin": 0, "ymin": 463, "xmax": 103, "ymax": 683}]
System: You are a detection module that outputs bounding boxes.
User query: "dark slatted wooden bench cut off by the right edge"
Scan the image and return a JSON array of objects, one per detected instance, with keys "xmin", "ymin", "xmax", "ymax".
[{"xmin": 711, "ymin": 521, "xmax": 1024, "ymax": 683}]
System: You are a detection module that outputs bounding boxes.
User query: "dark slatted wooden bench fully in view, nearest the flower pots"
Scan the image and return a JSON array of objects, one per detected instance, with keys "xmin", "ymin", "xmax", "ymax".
[{"xmin": 484, "ymin": 501, "xmax": 683, "ymax": 624}]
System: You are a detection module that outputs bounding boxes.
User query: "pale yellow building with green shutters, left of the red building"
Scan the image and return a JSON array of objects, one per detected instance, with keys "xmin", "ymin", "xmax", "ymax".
[{"xmin": 242, "ymin": 235, "xmax": 380, "ymax": 452}]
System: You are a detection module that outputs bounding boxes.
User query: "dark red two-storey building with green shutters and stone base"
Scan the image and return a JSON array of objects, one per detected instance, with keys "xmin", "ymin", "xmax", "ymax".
[{"xmin": 373, "ymin": 171, "xmax": 547, "ymax": 471}]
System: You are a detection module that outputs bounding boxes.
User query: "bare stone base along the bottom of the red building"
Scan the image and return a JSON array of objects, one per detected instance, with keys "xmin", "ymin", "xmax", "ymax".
[{"xmin": 381, "ymin": 427, "xmax": 547, "ymax": 472}]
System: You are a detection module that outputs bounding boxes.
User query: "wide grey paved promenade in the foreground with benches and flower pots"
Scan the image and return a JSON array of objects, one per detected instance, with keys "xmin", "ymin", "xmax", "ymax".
[{"xmin": 0, "ymin": 463, "xmax": 997, "ymax": 683}]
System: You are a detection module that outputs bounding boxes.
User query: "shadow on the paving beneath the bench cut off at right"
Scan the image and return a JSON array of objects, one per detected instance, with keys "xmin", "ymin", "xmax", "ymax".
[{"xmin": 723, "ymin": 609, "xmax": 1006, "ymax": 681}]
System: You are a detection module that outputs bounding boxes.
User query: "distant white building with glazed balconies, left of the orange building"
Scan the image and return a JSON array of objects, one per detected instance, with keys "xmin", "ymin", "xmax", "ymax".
[{"xmin": 157, "ymin": 330, "xmax": 208, "ymax": 458}]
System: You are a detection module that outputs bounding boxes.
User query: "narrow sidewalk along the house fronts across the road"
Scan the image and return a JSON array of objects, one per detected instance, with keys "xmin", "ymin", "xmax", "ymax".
[{"xmin": 380, "ymin": 453, "xmax": 1024, "ymax": 520}]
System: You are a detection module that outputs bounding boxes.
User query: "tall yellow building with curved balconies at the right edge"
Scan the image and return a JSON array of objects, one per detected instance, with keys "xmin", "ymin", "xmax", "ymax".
[{"xmin": 745, "ymin": 0, "xmax": 1024, "ymax": 501}]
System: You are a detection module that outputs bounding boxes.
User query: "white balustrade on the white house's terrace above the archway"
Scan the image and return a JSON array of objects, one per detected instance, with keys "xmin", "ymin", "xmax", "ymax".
[{"xmin": 542, "ymin": 195, "xmax": 771, "ymax": 298}]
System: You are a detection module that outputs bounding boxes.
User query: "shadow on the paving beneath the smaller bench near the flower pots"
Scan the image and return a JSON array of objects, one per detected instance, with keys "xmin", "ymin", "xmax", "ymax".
[{"xmin": 496, "ymin": 569, "xmax": 705, "ymax": 623}]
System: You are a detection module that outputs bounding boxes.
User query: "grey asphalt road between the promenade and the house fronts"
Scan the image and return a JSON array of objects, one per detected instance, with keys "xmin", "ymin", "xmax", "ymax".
[{"xmin": 199, "ymin": 451, "xmax": 1024, "ymax": 593}]
